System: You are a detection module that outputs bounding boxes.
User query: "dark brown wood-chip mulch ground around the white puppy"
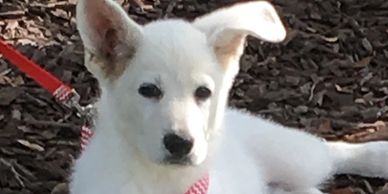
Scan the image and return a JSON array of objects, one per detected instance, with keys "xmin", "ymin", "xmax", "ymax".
[{"xmin": 0, "ymin": 0, "xmax": 388, "ymax": 194}]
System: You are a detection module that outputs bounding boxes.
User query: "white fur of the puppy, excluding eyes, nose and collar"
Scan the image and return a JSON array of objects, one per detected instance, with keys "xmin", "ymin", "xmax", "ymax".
[{"xmin": 71, "ymin": 0, "xmax": 388, "ymax": 194}]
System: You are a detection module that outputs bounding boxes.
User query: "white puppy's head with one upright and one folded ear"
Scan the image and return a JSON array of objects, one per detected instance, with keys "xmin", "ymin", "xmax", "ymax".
[{"xmin": 77, "ymin": 0, "xmax": 286, "ymax": 165}]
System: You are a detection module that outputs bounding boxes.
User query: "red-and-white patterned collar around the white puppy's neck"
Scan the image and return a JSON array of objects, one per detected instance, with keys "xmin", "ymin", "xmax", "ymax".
[{"xmin": 81, "ymin": 126, "xmax": 209, "ymax": 194}]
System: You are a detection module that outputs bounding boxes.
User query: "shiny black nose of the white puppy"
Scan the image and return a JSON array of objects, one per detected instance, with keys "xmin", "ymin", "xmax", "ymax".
[{"xmin": 163, "ymin": 133, "xmax": 193, "ymax": 159}]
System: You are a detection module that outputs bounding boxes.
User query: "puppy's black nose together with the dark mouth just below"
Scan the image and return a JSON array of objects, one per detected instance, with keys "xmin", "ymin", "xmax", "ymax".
[{"xmin": 163, "ymin": 133, "xmax": 194, "ymax": 164}]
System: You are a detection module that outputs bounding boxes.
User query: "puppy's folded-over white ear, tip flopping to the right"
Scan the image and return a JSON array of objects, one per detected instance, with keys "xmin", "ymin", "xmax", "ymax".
[{"xmin": 193, "ymin": 1, "xmax": 286, "ymax": 69}]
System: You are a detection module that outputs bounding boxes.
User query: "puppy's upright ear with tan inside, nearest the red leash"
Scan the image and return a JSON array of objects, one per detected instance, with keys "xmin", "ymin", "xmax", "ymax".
[{"xmin": 77, "ymin": 0, "xmax": 142, "ymax": 81}]
